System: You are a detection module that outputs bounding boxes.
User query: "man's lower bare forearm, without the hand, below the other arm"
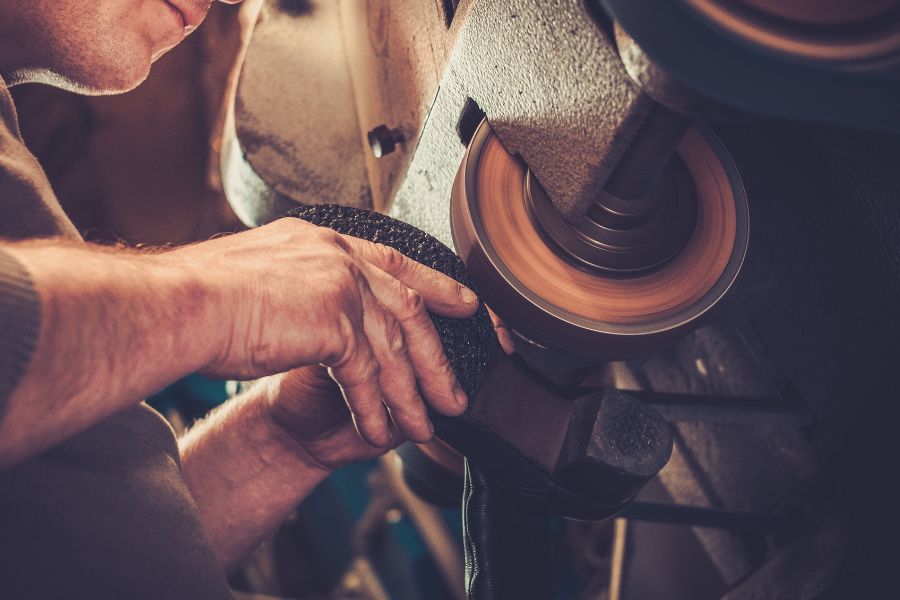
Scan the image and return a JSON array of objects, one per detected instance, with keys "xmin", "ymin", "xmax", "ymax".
[{"xmin": 179, "ymin": 385, "xmax": 329, "ymax": 571}]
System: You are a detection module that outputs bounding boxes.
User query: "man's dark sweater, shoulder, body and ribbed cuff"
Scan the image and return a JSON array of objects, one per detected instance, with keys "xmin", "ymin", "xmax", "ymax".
[{"xmin": 0, "ymin": 79, "xmax": 232, "ymax": 600}]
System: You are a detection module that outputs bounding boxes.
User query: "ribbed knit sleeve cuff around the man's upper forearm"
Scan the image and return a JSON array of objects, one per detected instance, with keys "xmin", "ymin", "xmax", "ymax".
[{"xmin": 0, "ymin": 249, "xmax": 41, "ymax": 417}]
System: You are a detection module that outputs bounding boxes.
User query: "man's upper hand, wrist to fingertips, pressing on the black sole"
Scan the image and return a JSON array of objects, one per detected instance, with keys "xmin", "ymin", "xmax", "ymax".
[{"xmin": 176, "ymin": 219, "xmax": 478, "ymax": 447}]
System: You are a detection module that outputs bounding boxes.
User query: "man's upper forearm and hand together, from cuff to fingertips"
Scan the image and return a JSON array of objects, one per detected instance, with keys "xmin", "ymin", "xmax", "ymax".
[{"xmin": 0, "ymin": 219, "xmax": 478, "ymax": 468}]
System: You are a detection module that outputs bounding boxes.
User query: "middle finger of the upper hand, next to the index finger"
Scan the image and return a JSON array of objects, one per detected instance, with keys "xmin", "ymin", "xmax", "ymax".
[{"xmin": 365, "ymin": 265, "xmax": 468, "ymax": 418}]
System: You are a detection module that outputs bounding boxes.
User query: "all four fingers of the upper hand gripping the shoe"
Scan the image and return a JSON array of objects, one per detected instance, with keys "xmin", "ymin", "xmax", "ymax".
[{"xmin": 320, "ymin": 236, "xmax": 478, "ymax": 447}]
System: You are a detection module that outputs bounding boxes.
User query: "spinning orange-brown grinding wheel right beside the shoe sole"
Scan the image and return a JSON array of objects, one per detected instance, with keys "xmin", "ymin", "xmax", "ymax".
[{"xmin": 451, "ymin": 120, "xmax": 749, "ymax": 358}]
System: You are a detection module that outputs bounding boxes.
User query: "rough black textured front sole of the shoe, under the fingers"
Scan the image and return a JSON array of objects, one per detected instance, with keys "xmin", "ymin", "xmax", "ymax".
[{"xmin": 287, "ymin": 204, "xmax": 498, "ymax": 398}]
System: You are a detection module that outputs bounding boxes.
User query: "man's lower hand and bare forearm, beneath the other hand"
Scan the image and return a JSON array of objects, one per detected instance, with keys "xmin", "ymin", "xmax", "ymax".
[{"xmin": 179, "ymin": 366, "xmax": 403, "ymax": 571}]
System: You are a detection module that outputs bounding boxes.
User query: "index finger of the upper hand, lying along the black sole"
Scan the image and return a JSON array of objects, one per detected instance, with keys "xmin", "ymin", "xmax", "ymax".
[{"xmin": 344, "ymin": 236, "xmax": 478, "ymax": 318}]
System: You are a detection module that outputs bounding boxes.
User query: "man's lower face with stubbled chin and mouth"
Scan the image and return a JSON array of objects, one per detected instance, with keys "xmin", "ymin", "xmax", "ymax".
[{"xmin": 0, "ymin": 0, "xmax": 240, "ymax": 94}]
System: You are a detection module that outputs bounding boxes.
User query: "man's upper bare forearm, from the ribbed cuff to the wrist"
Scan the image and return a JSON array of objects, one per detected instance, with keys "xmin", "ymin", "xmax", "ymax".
[{"xmin": 0, "ymin": 240, "xmax": 217, "ymax": 468}]
